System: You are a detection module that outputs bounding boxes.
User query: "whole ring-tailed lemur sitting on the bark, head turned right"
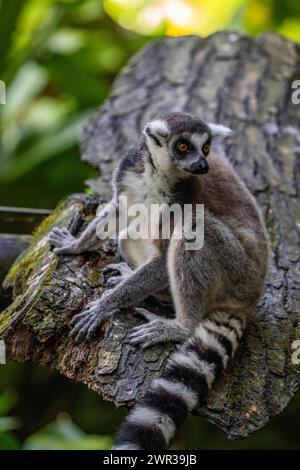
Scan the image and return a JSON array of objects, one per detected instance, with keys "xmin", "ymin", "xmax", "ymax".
[{"xmin": 50, "ymin": 113, "xmax": 268, "ymax": 450}]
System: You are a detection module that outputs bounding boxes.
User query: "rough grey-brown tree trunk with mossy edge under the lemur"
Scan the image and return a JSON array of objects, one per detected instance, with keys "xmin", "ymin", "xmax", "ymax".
[{"xmin": 0, "ymin": 32, "xmax": 300, "ymax": 438}]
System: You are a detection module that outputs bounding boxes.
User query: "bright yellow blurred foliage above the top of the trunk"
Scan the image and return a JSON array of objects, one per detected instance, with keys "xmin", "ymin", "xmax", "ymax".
[{"xmin": 103, "ymin": 0, "xmax": 300, "ymax": 40}]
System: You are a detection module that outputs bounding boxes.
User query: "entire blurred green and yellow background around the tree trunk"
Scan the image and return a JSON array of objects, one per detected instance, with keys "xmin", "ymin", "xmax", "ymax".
[{"xmin": 0, "ymin": 0, "xmax": 300, "ymax": 449}]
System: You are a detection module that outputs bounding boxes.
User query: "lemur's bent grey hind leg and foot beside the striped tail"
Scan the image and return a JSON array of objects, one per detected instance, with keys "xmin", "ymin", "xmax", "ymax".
[{"xmin": 130, "ymin": 216, "xmax": 247, "ymax": 347}]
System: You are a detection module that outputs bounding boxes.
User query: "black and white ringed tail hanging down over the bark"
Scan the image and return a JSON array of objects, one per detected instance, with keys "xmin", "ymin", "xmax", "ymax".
[{"xmin": 113, "ymin": 312, "xmax": 245, "ymax": 450}]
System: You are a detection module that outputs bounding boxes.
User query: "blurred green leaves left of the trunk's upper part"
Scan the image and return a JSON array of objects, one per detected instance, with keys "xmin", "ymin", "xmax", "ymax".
[{"xmin": 0, "ymin": 0, "xmax": 146, "ymax": 207}]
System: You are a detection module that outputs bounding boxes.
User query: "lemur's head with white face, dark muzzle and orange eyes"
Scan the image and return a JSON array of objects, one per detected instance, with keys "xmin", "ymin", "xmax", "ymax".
[{"xmin": 144, "ymin": 113, "xmax": 231, "ymax": 177}]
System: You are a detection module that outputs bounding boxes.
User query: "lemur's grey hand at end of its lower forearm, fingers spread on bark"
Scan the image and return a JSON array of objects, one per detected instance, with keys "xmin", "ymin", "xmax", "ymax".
[{"xmin": 70, "ymin": 300, "xmax": 112, "ymax": 342}]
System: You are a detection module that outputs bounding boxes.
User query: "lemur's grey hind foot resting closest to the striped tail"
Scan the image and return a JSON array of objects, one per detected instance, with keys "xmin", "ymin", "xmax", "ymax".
[{"xmin": 129, "ymin": 308, "xmax": 189, "ymax": 349}]
